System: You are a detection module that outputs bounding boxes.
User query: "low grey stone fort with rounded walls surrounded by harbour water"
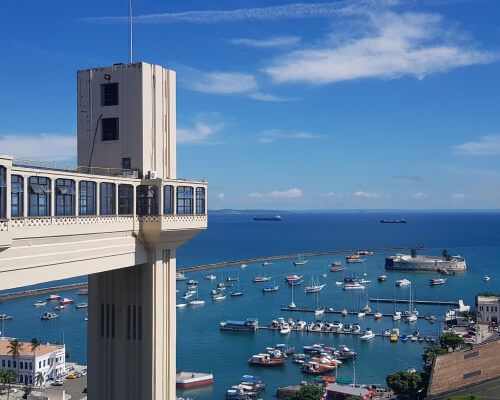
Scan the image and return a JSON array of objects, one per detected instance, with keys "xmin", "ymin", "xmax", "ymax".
[{"xmin": 385, "ymin": 254, "xmax": 467, "ymax": 272}]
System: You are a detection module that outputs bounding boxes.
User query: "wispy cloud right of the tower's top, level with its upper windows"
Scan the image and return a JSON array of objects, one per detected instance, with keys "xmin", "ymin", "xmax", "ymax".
[{"xmin": 178, "ymin": 66, "xmax": 293, "ymax": 101}]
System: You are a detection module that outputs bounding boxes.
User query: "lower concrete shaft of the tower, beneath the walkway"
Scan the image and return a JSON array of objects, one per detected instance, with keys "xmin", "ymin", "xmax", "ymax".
[{"xmin": 88, "ymin": 250, "xmax": 176, "ymax": 400}]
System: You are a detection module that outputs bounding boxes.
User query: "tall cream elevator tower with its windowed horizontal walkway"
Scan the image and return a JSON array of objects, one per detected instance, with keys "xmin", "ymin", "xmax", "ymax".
[{"xmin": 0, "ymin": 62, "xmax": 207, "ymax": 400}]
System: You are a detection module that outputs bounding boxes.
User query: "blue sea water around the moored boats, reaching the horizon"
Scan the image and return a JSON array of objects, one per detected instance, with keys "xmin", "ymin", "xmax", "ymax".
[{"xmin": 0, "ymin": 211, "xmax": 500, "ymax": 400}]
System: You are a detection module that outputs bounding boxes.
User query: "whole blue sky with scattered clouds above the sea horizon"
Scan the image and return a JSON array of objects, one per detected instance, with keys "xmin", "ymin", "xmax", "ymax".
[{"xmin": 0, "ymin": 0, "xmax": 500, "ymax": 209}]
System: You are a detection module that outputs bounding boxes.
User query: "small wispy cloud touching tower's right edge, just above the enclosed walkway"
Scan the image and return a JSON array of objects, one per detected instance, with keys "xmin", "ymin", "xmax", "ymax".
[{"xmin": 177, "ymin": 113, "xmax": 224, "ymax": 144}]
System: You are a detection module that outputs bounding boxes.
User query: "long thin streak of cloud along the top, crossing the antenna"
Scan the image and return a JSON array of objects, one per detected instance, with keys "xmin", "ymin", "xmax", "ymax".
[{"xmin": 83, "ymin": 0, "xmax": 399, "ymax": 24}]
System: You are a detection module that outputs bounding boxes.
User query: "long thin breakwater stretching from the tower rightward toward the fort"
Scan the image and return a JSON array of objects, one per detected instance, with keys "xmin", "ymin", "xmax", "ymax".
[{"xmin": 177, "ymin": 246, "xmax": 426, "ymax": 273}]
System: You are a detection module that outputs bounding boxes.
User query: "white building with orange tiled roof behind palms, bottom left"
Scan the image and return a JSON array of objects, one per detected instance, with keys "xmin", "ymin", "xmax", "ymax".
[{"xmin": 0, "ymin": 338, "xmax": 66, "ymax": 385}]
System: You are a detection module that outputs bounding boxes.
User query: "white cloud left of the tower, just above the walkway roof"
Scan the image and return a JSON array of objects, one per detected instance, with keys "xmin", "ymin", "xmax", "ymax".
[{"xmin": 0, "ymin": 133, "xmax": 76, "ymax": 161}]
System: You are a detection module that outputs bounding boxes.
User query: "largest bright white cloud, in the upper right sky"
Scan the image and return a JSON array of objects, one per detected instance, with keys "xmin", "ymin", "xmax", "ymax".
[{"xmin": 264, "ymin": 12, "xmax": 498, "ymax": 85}]
